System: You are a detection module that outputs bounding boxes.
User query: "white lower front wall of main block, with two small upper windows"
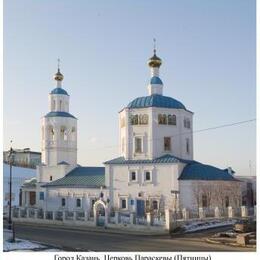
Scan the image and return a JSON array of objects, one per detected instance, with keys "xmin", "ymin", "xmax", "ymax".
[{"xmin": 106, "ymin": 164, "xmax": 182, "ymax": 210}]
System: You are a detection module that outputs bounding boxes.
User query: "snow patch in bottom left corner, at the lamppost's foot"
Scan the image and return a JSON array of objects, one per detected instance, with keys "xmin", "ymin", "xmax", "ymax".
[{"xmin": 3, "ymin": 230, "xmax": 60, "ymax": 252}]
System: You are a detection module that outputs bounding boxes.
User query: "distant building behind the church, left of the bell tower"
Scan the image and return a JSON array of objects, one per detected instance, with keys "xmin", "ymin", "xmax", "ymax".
[{"xmin": 3, "ymin": 148, "xmax": 41, "ymax": 169}]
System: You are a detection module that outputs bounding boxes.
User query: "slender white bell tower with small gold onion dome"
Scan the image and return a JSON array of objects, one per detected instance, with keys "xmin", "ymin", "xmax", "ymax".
[{"xmin": 41, "ymin": 60, "xmax": 77, "ymax": 166}]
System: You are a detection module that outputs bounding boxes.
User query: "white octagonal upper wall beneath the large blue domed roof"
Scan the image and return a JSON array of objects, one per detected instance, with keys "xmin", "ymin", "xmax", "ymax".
[{"xmin": 119, "ymin": 107, "xmax": 193, "ymax": 160}]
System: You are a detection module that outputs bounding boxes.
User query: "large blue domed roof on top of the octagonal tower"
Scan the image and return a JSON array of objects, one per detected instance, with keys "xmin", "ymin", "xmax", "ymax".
[{"xmin": 127, "ymin": 94, "xmax": 187, "ymax": 110}]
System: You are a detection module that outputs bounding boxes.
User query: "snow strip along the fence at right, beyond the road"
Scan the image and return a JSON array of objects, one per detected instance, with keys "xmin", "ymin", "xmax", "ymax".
[{"xmin": 183, "ymin": 220, "xmax": 236, "ymax": 233}]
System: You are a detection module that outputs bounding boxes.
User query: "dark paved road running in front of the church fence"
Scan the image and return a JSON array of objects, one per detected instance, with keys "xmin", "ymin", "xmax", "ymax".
[{"xmin": 7, "ymin": 223, "xmax": 254, "ymax": 251}]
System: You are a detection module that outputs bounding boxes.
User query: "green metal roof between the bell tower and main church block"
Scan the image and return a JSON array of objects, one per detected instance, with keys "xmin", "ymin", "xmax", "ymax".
[{"xmin": 42, "ymin": 167, "xmax": 105, "ymax": 188}]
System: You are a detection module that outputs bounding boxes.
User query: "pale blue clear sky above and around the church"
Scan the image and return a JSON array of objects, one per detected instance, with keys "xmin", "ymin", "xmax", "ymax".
[{"xmin": 3, "ymin": 0, "xmax": 256, "ymax": 175}]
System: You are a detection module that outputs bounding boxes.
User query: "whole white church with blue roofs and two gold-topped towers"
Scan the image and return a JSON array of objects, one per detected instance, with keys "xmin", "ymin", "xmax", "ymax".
[{"xmin": 22, "ymin": 50, "xmax": 241, "ymax": 216}]
